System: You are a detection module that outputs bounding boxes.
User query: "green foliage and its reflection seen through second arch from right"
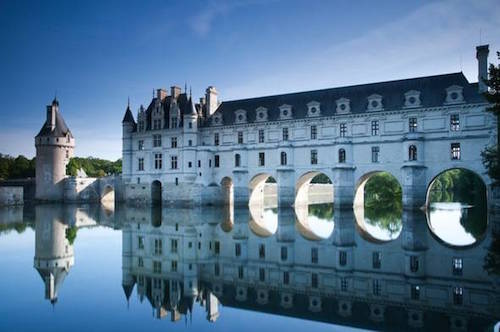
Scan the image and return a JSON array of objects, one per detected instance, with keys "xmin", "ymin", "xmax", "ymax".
[{"xmin": 364, "ymin": 172, "xmax": 403, "ymax": 234}]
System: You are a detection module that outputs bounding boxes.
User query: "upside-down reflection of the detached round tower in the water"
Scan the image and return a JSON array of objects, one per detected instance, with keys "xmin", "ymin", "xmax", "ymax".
[{"xmin": 34, "ymin": 206, "xmax": 74, "ymax": 303}]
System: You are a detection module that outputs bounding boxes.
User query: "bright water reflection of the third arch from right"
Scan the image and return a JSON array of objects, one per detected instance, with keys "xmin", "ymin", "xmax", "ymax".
[{"xmin": 295, "ymin": 204, "xmax": 334, "ymax": 241}]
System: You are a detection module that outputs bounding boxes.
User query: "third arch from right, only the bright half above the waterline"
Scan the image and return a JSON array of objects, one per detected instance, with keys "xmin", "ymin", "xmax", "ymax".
[{"xmin": 295, "ymin": 171, "xmax": 333, "ymax": 206}]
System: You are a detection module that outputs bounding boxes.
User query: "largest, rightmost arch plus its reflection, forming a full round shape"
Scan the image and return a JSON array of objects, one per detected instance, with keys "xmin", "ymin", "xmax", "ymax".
[{"xmin": 426, "ymin": 168, "xmax": 488, "ymax": 246}]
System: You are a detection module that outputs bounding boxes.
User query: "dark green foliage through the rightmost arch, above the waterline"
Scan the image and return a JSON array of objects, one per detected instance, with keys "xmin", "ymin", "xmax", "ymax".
[{"xmin": 429, "ymin": 168, "xmax": 486, "ymax": 205}]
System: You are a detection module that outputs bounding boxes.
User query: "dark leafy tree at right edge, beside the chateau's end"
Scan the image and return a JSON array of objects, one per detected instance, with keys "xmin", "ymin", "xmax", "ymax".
[{"xmin": 481, "ymin": 52, "xmax": 500, "ymax": 183}]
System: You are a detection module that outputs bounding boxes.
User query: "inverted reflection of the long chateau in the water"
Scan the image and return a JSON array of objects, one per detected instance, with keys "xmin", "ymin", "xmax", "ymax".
[{"xmin": 120, "ymin": 209, "xmax": 499, "ymax": 330}]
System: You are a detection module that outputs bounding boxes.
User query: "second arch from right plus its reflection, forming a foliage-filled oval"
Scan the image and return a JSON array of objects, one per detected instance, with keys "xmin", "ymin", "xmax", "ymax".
[{"xmin": 354, "ymin": 171, "xmax": 403, "ymax": 242}]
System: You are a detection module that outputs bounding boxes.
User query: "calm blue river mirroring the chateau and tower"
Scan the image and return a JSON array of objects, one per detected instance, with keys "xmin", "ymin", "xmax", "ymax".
[{"xmin": 0, "ymin": 203, "xmax": 500, "ymax": 331}]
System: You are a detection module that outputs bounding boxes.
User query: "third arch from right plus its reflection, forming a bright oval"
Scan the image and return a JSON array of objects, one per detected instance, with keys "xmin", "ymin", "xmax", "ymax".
[{"xmin": 294, "ymin": 172, "xmax": 334, "ymax": 240}]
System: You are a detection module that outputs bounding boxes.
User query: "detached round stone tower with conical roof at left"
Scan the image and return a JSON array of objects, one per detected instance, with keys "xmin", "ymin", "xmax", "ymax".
[{"xmin": 35, "ymin": 98, "xmax": 75, "ymax": 201}]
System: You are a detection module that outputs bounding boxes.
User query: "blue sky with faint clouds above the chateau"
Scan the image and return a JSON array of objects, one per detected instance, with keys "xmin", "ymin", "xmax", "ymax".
[{"xmin": 0, "ymin": 0, "xmax": 500, "ymax": 159}]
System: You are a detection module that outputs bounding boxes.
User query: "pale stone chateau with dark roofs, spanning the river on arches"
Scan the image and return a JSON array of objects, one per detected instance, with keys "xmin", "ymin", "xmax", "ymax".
[{"xmin": 122, "ymin": 45, "xmax": 497, "ymax": 207}]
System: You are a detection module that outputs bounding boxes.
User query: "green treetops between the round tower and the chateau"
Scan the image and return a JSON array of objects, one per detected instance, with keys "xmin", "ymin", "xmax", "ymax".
[{"xmin": 66, "ymin": 157, "xmax": 122, "ymax": 177}]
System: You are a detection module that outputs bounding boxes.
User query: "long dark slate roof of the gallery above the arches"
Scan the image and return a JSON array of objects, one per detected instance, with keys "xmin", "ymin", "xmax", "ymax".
[{"xmin": 212, "ymin": 72, "xmax": 483, "ymax": 125}]
